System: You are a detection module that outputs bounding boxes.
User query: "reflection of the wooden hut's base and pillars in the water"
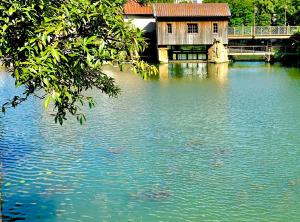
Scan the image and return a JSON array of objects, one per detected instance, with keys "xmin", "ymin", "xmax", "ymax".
[{"xmin": 159, "ymin": 63, "xmax": 228, "ymax": 83}]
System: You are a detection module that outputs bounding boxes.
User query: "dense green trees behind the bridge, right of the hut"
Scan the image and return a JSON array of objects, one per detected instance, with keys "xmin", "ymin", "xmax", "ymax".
[{"xmin": 203, "ymin": 0, "xmax": 300, "ymax": 26}]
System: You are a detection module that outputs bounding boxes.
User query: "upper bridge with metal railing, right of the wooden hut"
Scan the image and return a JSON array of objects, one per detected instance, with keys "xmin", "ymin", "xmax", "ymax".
[{"xmin": 228, "ymin": 26, "xmax": 300, "ymax": 40}]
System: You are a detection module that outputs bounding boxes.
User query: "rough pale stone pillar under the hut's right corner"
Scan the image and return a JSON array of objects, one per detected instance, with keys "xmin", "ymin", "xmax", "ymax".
[{"xmin": 208, "ymin": 39, "xmax": 229, "ymax": 63}]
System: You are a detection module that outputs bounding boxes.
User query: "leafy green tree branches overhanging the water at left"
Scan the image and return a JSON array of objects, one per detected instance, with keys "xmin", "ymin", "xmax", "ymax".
[{"xmin": 0, "ymin": 0, "xmax": 156, "ymax": 124}]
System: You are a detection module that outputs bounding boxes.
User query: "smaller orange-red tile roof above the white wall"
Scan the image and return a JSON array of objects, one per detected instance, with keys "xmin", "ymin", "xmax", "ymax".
[{"xmin": 123, "ymin": 0, "xmax": 153, "ymax": 15}]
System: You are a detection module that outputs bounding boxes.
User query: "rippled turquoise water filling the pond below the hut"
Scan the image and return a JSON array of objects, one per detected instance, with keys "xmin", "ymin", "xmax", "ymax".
[{"xmin": 0, "ymin": 63, "xmax": 300, "ymax": 222}]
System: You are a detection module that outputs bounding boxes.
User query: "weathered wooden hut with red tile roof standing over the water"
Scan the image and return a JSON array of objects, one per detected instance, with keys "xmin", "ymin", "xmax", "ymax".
[{"xmin": 153, "ymin": 3, "xmax": 231, "ymax": 62}]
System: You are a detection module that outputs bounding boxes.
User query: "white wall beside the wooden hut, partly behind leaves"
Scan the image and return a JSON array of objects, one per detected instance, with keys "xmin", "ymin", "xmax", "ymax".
[{"xmin": 124, "ymin": 15, "xmax": 155, "ymax": 32}]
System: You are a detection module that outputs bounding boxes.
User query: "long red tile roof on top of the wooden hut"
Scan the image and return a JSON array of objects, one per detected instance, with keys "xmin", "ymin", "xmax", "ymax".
[{"xmin": 153, "ymin": 3, "xmax": 231, "ymax": 17}]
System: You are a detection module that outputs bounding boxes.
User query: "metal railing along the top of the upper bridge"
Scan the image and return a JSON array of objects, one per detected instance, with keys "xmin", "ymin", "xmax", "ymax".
[{"xmin": 228, "ymin": 26, "xmax": 300, "ymax": 36}]
